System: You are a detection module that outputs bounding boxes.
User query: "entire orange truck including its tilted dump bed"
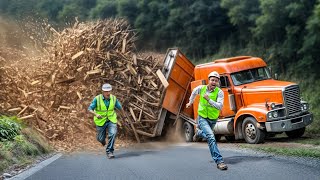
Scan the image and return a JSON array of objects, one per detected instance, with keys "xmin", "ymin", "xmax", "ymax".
[{"xmin": 151, "ymin": 48, "xmax": 313, "ymax": 144}]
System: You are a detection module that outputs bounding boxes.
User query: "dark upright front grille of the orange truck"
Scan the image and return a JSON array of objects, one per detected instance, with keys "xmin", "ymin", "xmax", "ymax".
[{"xmin": 283, "ymin": 85, "xmax": 301, "ymax": 116}]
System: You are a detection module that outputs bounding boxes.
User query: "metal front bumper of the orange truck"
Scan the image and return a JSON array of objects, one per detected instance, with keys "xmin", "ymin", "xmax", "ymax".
[{"xmin": 266, "ymin": 113, "xmax": 313, "ymax": 132}]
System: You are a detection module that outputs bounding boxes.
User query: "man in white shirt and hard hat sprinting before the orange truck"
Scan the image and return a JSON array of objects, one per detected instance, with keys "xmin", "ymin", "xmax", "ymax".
[{"xmin": 186, "ymin": 71, "xmax": 228, "ymax": 170}]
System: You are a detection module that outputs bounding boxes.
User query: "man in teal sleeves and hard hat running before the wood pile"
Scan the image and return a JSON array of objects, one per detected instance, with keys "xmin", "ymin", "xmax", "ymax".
[{"xmin": 88, "ymin": 83, "xmax": 122, "ymax": 159}]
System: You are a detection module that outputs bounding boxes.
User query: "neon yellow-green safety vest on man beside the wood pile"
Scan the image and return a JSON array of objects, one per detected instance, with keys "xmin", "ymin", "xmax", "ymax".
[{"xmin": 93, "ymin": 94, "xmax": 117, "ymax": 126}]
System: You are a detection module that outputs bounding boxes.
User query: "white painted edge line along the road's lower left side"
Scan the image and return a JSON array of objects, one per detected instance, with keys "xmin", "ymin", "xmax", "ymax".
[{"xmin": 7, "ymin": 153, "xmax": 62, "ymax": 180}]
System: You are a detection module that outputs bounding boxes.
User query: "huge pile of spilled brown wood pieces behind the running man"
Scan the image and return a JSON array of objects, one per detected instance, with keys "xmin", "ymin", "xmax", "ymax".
[{"xmin": 0, "ymin": 19, "xmax": 168, "ymax": 149}]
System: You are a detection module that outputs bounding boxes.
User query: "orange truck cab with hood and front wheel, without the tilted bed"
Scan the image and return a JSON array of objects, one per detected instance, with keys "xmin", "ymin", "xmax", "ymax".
[{"xmin": 182, "ymin": 56, "xmax": 313, "ymax": 144}]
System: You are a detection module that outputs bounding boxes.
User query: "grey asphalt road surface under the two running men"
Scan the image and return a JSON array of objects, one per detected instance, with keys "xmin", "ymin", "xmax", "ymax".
[{"xmin": 19, "ymin": 143, "xmax": 320, "ymax": 180}]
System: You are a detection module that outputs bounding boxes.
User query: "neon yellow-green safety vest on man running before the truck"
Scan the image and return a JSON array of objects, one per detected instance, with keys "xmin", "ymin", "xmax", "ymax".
[{"xmin": 198, "ymin": 86, "xmax": 220, "ymax": 120}]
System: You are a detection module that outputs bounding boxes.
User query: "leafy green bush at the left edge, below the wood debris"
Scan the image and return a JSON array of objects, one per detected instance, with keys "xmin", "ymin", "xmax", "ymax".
[{"xmin": 0, "ymin": 116, "xmax": 21, "ymax": 141}]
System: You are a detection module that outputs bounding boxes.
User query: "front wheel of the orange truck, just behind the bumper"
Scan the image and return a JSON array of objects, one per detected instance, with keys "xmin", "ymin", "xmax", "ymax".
[{"xmin": 242, "ymin": 117, "xmax": 266, "ymax": 144}]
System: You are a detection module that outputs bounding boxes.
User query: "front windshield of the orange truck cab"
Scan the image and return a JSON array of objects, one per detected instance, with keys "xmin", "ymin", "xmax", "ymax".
[{"xmin": 231, "ymin": 67, "xmax": 271, "ymax": 86}]
